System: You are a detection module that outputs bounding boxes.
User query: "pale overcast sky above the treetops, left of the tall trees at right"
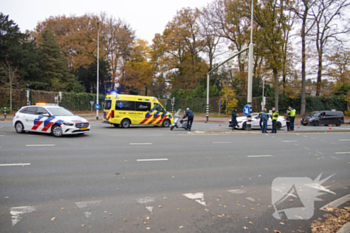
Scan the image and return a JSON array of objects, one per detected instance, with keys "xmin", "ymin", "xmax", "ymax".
[{"xmin": 0, "ymin": 0, "xmax": 211, "ymax": 43}]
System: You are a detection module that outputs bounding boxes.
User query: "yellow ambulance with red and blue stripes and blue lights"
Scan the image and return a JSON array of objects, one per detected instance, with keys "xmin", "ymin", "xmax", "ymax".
[{"xmin": 103, "ymin": 92, "xmax": 174, "ymax": 128}]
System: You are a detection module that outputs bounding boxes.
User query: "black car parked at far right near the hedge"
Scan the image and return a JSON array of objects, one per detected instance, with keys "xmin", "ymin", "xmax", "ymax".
[{"xmin": 301, "ymin": 110, "xmax": 344, "ymax": 126}]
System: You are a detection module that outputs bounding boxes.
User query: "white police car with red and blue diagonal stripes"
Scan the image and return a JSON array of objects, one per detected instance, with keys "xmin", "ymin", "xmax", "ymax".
[{"xmin": 12, "ymin": 103, "xmax": 90, "ymax": 137}]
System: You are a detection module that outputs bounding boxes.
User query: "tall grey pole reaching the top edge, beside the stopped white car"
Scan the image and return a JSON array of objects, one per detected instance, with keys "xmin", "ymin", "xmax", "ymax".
[{"xmin": 246, "ymin": 0, "xmax": 254, "ymax": 131}]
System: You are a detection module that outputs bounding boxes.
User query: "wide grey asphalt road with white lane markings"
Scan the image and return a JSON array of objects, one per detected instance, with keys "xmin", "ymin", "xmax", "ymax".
[{"xmin": 0, "ymin": 122, "xmax": 350, "ymax": 232}]
